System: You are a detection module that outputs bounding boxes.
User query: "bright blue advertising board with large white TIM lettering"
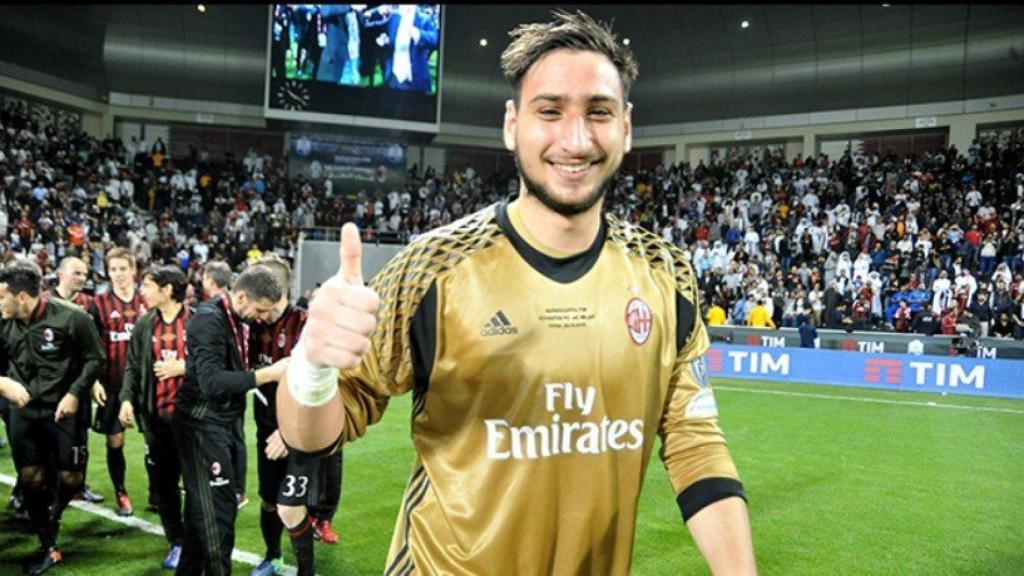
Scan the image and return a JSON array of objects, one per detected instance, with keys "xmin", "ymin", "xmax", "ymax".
[{"xmin": 705, "ymin": 343, "xmax": 1024, "ymax": 399}]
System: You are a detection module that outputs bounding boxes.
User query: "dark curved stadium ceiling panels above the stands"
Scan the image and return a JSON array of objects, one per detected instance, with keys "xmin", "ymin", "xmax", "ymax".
[{"xmin": 0, "ymin": 3, "xmax": 1024, "ymax": 125}]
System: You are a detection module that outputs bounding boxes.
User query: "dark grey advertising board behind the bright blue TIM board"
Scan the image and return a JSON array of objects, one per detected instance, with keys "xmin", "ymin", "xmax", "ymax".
[{"xmin": 708, "ymin": 326, "xmax": 1024, "ymax": 360}]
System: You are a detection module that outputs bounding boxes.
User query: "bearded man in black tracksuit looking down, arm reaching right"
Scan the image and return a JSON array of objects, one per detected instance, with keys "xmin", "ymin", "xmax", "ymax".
[{"xmin": 171, "ymin": 265, "xmax": 288, "ymax": 576}]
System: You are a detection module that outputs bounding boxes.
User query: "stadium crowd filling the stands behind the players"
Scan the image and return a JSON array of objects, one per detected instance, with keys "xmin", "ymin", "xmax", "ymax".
[{"xmin": 0, "ymin": 96, "xmax": 1024, "ymax": 339}]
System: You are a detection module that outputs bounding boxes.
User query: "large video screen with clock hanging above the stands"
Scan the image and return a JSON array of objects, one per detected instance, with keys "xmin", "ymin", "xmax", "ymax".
[{"xmin": 264, "ymin": 4, "xmax": 443, "ymax": 132}]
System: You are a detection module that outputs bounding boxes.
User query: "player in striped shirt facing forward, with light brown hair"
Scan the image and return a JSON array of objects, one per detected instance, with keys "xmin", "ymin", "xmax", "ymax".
[{"xmin": 91, "ymin": 243, "xmax": 146, "ymax": 516}]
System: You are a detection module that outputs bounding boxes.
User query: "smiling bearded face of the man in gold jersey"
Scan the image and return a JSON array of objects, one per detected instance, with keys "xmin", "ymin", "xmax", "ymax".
[{"xmin": 504, "ymin": 49, "xmax": 632, "ymax": 216}]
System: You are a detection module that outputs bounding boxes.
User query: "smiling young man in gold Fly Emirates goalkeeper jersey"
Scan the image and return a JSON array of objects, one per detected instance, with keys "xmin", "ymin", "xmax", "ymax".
[{"xmin": 278, "ymin": 8, "xmax": 756, "ymax": 575}]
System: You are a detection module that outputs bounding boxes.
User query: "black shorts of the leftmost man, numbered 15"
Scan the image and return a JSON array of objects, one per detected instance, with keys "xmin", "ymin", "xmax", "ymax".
[{"xmin": 10, "ymin": 409, "xmax": 88, "ymax": 471}]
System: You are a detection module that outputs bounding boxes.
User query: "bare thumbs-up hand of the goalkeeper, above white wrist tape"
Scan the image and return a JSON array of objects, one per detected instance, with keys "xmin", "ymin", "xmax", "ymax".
[{"xmin": 300, "ymin": 219, "xmax": 380, "ymax": 369}]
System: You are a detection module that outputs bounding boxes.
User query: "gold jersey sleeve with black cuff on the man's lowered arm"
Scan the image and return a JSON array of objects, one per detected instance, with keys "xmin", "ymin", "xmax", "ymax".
[{"xmin": 658, "ymin": 262, "xmax": 745, "ymax": 521}]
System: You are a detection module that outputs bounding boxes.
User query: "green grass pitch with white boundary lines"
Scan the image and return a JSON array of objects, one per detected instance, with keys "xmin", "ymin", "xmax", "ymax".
[{"xmin": 0, "ymin": 379, "xmax": 1024, "ymax": 576}]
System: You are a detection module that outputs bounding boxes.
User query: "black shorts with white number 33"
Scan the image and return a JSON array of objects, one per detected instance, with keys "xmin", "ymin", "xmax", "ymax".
[{"xmin": 256, "ymin": 426, "xmax": 327, "ymax": 506}]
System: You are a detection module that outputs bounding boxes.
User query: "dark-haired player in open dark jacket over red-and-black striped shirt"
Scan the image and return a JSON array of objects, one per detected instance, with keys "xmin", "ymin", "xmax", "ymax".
[{"xmin": 112, "ymin": 265, "xmax": 189, "ymax": 570}]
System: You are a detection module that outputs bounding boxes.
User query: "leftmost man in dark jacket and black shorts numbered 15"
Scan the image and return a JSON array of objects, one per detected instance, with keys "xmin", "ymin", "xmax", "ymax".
[{"xmin": 0, "ymin": 260, "xmax": 105, "ymax": 574}]
